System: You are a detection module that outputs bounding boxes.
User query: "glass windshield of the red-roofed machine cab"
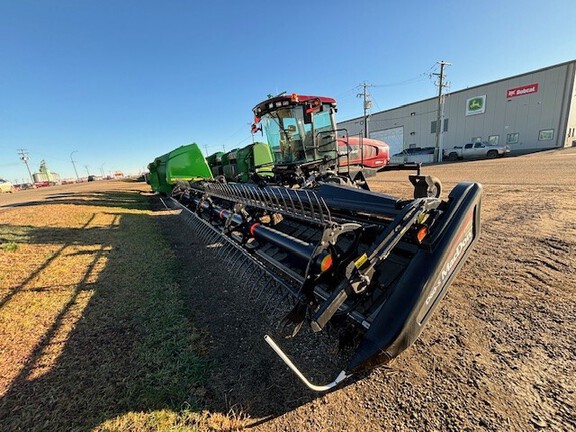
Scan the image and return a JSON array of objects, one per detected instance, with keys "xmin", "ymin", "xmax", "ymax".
[{"xmin": 261, "ymin": 106, "xmax": 337, "ymax": 164}]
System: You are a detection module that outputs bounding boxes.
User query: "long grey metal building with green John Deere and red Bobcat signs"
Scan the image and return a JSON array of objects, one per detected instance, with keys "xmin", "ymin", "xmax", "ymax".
[{"xmin": 338, "ymin": 60, "xmax": 576, "ymax": 154}]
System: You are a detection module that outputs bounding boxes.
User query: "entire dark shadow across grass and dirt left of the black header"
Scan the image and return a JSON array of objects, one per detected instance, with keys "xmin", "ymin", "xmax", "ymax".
[{"xmin": 0, "ymin": 188, "xmax": 324, "ymax": 431}]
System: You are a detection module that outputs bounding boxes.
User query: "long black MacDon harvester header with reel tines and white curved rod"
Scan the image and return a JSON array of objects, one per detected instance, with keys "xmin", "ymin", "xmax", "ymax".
[{"xmin": 172, "ymin": 182, "xmax": 482, "ymax": 391}]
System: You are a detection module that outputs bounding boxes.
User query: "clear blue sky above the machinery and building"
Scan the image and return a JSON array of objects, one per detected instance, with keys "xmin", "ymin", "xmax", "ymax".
[{"xmin": 0, "ymin": 0, "xmax": 576, "ymax": 182}]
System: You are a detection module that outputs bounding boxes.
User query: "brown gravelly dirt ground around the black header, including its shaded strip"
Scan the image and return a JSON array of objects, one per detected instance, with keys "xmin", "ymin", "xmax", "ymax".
[{"xmin": 164, "ymin": 148, "xmax": 576, "ymax": 431}]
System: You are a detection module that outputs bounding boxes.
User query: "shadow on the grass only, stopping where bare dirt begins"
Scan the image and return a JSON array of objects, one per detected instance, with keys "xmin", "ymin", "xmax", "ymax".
[{"xmin": 0, "ymin": 193, "xmax": 205, "ymax": 431}]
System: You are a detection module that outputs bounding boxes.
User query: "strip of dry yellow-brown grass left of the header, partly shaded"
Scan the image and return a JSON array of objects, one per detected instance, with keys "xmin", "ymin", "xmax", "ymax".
[{"xmin": 0, "ymin": 183, "xmax": 241, "ymax": 431}]
